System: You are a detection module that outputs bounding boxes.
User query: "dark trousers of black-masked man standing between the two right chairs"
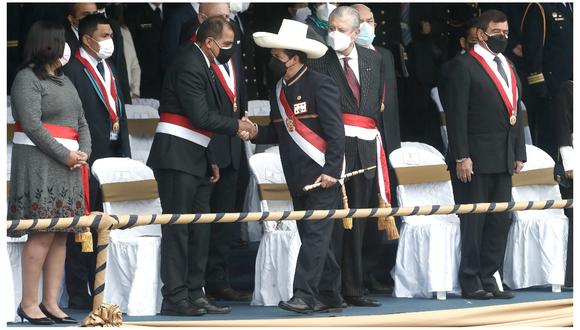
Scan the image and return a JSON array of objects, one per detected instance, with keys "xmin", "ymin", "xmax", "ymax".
[{"xmin": 451, "ymin": 172, "xmax": 512, "ymax": 292}]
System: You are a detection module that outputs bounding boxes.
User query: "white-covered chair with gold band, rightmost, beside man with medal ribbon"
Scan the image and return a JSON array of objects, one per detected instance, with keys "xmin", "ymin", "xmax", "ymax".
[{"xmin": 503, "ymin": 145, "xmax": 568, "ymax": 292}]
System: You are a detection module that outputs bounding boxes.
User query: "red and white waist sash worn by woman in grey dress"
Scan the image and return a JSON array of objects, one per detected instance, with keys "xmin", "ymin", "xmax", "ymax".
[{"xmin": 12, "ymin": 122, "xmax": 91, "ymax": 215}]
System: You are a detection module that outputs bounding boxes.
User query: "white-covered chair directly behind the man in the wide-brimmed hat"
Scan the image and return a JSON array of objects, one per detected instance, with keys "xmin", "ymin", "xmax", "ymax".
[{"xmin": 250, "ymin": 152, "xmax": 301, "ymax": 306}]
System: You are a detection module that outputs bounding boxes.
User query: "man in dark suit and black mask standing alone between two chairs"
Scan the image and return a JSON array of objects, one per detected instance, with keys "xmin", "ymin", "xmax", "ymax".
[{"xmin": 444, "ymin": 10, "xmax": 526, "ymax": 299}]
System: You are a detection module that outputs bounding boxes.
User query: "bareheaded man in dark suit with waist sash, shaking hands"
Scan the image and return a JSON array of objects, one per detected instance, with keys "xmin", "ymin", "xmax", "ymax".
[{"xmin": 147, "ymin": 17, "xmax": 255, "ymax": 316}]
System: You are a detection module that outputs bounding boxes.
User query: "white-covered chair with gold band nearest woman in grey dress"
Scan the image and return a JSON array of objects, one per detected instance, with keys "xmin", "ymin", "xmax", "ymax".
[{"xmin": 92, "ymin": 157, "xmax": 162, "ymax": 315}]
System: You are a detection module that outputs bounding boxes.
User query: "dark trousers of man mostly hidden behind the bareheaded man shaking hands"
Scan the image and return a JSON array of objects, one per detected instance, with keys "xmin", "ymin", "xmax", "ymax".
[{"xmin": 205, "ymin": 165, "xmax": 238, "ymax": 292}]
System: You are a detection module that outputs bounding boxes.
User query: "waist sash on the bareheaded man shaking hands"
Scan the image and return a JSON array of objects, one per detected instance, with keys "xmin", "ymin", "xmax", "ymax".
[{"xmin": 155, "ymin": 112, "xmax": 212, "ymax": 148}]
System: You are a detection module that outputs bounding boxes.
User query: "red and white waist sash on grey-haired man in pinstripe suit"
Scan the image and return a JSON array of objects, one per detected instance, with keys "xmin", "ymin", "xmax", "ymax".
[{"xmin": 342, "ymin": 113, "xmax": 391, "ymax": 203}]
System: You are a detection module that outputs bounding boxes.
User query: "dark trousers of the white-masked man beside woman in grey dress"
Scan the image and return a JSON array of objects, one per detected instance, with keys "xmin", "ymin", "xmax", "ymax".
[{"xmin": 65, "ymin": 142, "xmax": 123, "ymax": 304}]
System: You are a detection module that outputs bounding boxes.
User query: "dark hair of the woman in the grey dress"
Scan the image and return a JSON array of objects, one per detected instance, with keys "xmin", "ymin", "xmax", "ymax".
[{"xmin": 20, "ymin": 21, "xmax": 66, "ymax": 80}]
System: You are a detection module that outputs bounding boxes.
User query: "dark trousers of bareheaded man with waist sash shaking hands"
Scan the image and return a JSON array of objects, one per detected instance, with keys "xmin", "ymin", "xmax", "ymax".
[{"xmin": 154, "ymin": 169, "xmax": 212, "ymax": 302}]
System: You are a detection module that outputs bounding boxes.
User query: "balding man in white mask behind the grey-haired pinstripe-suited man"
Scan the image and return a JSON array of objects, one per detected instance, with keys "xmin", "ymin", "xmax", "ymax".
[{"xmin": 351, "ymin": 4, "xmax": 401, "ymax": 293}]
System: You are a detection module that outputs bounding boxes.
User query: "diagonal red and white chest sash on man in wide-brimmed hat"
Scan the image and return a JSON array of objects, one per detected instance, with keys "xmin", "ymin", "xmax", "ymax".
[{"xmin": 276, "ymin": 78, "xmax": 326, "ymax": 166}]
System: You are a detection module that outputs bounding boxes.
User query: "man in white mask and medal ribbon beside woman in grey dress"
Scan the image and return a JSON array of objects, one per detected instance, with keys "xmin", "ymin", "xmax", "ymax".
[{"xmin": 63, "ymin": 14, "xmax": 131, "ymax": 308}]
